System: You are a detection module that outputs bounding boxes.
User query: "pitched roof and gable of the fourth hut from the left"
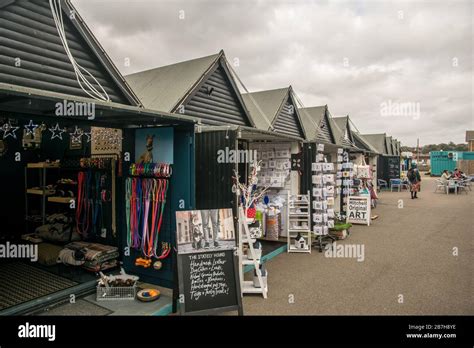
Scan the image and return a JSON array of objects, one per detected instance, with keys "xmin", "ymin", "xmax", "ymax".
[{"xmin": 299, "ymin": 105, "xmax": 335, "ymax": 144}]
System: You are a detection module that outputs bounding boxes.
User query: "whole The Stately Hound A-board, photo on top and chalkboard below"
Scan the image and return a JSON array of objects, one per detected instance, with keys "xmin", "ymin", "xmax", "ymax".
[{"xmin": 176, "ymin": 209, "xmax": 242, "ymax": 315}]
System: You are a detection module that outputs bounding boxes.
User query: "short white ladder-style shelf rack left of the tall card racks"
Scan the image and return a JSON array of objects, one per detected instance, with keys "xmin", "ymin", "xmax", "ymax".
[{"xmin": 286, "ymin": 191, "xmax": 311, "ymax": 253}]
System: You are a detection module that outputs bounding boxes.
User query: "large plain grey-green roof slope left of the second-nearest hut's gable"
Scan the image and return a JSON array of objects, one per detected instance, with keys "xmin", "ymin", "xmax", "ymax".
[{"xmin": 125, "ymin": 51, "xmax": 219, "ymax": 112}]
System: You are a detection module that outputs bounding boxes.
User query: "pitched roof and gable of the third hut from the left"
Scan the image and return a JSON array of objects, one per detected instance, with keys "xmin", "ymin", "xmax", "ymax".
[{"xmin": 242, "ymin": 86, "xmax": 306, "ymax": 138}]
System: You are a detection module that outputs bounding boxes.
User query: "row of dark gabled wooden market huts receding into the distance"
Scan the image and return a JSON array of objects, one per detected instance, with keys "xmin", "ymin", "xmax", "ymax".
[{"xmin": 0, "ymin": 0, "xmax": 400, "ymax": 310}]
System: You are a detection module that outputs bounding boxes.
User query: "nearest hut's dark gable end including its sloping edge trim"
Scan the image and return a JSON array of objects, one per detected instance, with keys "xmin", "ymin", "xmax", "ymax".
[{"xmin": 0, "ymin": 0, "xmax": 140, "ymax": 105}]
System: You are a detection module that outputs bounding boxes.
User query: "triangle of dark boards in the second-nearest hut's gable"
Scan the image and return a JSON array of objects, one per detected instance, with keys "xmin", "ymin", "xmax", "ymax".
[{"xmin": 185, "ymin": 66, "xmax": 249, "ymax": 126}]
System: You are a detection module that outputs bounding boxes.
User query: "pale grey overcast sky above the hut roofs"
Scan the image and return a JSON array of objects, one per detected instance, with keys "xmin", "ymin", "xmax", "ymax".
[{"xmin": 73, "ymin": 0, "xmax": 474, "ymax": 145}]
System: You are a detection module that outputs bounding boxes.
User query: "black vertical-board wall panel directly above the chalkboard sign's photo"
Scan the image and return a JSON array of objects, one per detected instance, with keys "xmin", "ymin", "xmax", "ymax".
[{"xmin": 195, "ymin": 131, "xmax": 236, "ymax": 209}]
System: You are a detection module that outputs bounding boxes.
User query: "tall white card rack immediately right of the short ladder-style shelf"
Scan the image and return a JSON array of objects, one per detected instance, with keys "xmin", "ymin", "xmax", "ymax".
[{"xmin": 312, "ymin": 144, "xmax": 336, "ymax": 252}]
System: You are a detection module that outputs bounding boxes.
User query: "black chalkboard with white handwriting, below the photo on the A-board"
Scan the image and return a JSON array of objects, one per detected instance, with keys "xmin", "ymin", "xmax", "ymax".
[{"xmin": 178, "ymin": 250, "xmax": 242, "ymax": 314}]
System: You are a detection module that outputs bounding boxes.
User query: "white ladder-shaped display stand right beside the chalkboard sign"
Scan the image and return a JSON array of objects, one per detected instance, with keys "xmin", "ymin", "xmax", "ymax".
[{"xmin": 237, "ymin": 207, "xmax": 268, "ymax": 298}]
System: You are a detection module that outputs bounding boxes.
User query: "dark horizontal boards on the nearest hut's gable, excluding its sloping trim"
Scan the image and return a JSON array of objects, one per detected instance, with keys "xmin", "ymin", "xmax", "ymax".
[{"xmin": 0, "ymin": 0, "xmax": 128, "ymax": 104}]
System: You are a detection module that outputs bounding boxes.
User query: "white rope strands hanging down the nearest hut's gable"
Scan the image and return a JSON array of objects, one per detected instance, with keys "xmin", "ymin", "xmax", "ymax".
[{"xmin": 49, "ymin": 0, "xmax": 110, "ymax": 101}]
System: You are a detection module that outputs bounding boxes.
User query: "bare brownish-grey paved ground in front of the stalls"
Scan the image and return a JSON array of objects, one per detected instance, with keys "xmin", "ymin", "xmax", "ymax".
[{"xmin": 243, "ymin": 177, "xmax": 474, "ymax": 315}]
